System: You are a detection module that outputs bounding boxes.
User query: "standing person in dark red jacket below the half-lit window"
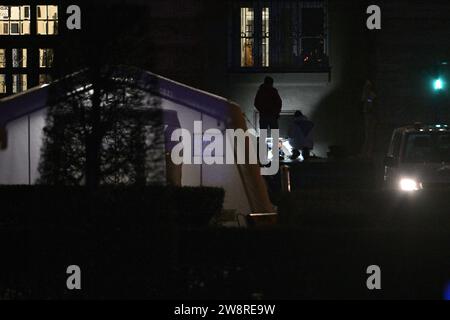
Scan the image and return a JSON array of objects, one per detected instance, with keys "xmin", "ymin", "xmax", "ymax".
[{"xmin": 255, "ymin": 77, "xmax": 282, "ymax": 129}]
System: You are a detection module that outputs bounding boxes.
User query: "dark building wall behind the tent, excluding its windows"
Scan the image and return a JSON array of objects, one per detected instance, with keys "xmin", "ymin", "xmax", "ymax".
[{"xmin": 6, "ymin": 0, "xmax": 450, "ymax": 156}]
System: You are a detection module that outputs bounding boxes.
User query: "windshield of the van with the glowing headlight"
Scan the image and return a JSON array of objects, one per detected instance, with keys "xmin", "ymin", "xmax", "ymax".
[{"xmin": 403, "ymin": 132, "xmax": 450, "ymax": 163}]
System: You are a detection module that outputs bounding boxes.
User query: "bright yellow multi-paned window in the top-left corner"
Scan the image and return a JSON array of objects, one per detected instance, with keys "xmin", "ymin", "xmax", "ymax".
[{"xmin": 0, "ymin": 6, "xmax": 30, "ymax": 35}]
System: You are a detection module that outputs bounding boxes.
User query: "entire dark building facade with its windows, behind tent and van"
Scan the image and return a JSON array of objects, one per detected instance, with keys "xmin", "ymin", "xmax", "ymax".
[{"xmin": 0, "ymin": 0, "xmax": 450, "ymax": 156}]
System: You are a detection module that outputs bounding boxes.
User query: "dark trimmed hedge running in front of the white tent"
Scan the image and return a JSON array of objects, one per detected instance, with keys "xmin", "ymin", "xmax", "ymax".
[{"xmin": 0, "ymin": 186, "xmax": 224, "ymax": 229}]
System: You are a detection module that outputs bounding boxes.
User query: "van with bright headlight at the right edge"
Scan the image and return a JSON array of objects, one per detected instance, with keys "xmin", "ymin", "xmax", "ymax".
[{"xmin": 384, "ymin": 123, "xmax": 450, "ymax": 192}]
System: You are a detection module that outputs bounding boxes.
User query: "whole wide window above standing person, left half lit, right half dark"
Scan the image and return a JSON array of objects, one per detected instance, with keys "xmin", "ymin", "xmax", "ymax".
[{"xmin": 232, "ymin": 0, "xmax": 329, "ymax": 72}]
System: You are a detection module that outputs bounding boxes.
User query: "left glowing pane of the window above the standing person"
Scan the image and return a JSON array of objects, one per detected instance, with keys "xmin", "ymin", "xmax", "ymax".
[{"xmin": 241, "ymin": 8, "xmax": 255, "ymax": 67}]
